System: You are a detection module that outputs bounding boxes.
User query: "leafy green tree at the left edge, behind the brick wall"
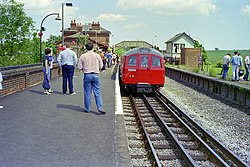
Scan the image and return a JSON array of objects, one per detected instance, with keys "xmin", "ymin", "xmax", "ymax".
[{"xmin": 0, "ymin": 0, "xmax": 35, "ymax": 66}]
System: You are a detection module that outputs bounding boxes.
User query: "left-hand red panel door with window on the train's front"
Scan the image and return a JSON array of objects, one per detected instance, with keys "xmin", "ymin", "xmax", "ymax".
[{"xmin": 124, "ymin": 55, "xmax": 138, "ymax": 84}]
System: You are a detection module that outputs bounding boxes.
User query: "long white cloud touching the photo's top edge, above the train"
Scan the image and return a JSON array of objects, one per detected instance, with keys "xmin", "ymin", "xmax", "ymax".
[{"xmin": 116, "ymin": 0, "xmax": 217, "ymax": 15}]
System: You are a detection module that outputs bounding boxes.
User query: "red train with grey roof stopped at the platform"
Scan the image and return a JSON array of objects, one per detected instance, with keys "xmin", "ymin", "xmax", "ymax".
[{"xmin": 119, "ymin": 48, "xmax": 165, "ymax": 93}]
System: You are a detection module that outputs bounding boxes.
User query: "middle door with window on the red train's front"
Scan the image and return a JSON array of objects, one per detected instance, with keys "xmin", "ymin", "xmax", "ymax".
[{"xmin": 137, "ymin": 54, "xmax": 150, "ymax": 84}]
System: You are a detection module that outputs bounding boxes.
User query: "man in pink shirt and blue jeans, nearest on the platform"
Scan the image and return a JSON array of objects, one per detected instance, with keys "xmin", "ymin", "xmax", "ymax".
[{"xmin": 78, "ymin": 42, "xmax": 106, "ymax": 114}]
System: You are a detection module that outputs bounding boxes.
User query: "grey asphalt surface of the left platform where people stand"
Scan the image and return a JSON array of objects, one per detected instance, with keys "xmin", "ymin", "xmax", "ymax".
[{"xmin": 0, "ymin": 65, "xmax": 127, "ymax": 167}]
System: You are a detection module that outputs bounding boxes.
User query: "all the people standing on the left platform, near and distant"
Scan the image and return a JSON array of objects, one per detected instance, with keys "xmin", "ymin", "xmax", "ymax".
[{"xmin": 42, "ymin": 42, "xmax": 119, "ymax": 114}]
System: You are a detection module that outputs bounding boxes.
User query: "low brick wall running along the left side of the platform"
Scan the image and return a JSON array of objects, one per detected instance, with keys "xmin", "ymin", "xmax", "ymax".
[{"xmin": 0, "ymin": 63, "xmax": 60, "ymax": 97}]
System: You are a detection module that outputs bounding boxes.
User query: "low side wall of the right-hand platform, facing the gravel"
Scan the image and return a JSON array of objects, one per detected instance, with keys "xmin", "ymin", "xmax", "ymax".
[{"xmin": 166, "ymin": 67, "xmax": 250, "ymax": 107}]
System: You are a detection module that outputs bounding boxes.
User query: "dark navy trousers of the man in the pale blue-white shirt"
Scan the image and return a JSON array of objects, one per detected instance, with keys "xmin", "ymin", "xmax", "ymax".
[{"xmin": 62, "ymin": 65, "xmax": 75, "ymax": 94}]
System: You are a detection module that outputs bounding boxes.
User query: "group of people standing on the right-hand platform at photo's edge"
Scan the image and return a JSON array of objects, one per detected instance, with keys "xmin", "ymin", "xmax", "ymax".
[{"xmin": 222, "ymin": 51, "xmax": 250, "ymax": 81}]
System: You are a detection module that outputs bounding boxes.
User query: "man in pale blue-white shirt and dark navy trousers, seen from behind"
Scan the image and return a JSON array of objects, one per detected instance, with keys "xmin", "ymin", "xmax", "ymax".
[{"xmin": 57, "ymin": 43, "xmax": 77, "ymax": 95}]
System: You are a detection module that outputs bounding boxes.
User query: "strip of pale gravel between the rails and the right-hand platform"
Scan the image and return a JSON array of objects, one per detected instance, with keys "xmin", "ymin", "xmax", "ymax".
[{"xmin": 161, "ymin": 78, "xmax": 250, "ymax": 165}]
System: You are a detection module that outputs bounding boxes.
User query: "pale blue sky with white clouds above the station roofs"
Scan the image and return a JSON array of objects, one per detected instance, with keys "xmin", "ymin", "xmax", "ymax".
[{"xmin": 10, "ymin": 0, "xmax": 250, "ymax": 50}]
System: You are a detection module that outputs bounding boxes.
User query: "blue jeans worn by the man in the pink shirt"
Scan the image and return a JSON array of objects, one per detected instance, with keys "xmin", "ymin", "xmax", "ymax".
[{"xmin": 83, "ymin": 74, "xmax": 103, "ymax": 112}]
